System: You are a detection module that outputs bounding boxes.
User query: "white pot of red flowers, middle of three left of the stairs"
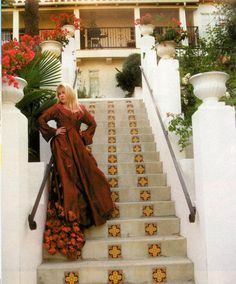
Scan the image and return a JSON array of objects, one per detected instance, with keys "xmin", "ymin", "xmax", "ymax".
[{"xmin": 40, "ymin": 28, "xmax": 69, "ymax": 57}]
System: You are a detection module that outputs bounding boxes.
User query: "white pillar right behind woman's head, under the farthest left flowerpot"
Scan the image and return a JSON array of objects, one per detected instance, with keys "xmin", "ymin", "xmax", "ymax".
[{"xmin": 61, "ymin": 38, "xmax": 76, "ymax": 86}]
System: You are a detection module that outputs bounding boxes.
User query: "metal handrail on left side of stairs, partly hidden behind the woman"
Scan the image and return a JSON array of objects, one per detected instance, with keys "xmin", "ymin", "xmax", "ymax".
[{"xmin": 28, "ymin": 69, "xmax": 78, "ymax": 230}]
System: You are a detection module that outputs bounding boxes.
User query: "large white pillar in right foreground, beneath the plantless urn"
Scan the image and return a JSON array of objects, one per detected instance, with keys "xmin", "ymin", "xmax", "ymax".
[{"xmin": 193, "ymin": 102, "xmax": 236, "ymax": 284}]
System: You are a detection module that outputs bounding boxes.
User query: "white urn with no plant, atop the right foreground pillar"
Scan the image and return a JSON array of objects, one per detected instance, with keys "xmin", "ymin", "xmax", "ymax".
[{"xmin": 189, "ymin": 71, "xmax": 229, "ymax": 102}]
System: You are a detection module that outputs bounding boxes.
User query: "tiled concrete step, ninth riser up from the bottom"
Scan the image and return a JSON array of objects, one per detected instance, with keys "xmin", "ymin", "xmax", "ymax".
[{"xmin": 90, "ymin": 142, "xmax": 156, "ymax": 153}]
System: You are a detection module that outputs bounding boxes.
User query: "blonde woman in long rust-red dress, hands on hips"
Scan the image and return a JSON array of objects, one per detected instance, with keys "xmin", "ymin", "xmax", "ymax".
[{"xmin": 38, "ymin": 84, "xmax": 114, "ymax": 259}]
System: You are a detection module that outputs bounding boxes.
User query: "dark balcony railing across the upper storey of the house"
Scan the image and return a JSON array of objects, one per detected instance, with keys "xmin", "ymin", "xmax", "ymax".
[{"xmin": 2, "ymin": 26, "xmax": 198, "ymax": 49}]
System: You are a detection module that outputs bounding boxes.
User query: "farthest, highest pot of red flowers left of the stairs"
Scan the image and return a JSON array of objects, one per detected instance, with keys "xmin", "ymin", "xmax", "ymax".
[{"xmin": 51, "ymin": 13, "xmax": 81, "ymax": 37}]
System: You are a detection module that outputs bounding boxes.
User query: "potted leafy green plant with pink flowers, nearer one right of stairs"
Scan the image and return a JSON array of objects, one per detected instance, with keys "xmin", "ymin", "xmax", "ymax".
[{"xmin": 155, "ymin": 18, "xmax": 187, "ymax": 59}]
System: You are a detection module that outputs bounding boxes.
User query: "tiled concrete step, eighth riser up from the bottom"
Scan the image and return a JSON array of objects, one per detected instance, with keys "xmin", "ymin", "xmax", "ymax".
[{"xmin": 93, "ymin": 152, "xmax": 159, "ymax": 164}]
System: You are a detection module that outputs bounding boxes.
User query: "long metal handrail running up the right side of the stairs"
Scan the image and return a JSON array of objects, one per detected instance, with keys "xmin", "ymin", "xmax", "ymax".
[{"xmin": 140, "ymin": 67, "xmax": 196, "ymax": 223}]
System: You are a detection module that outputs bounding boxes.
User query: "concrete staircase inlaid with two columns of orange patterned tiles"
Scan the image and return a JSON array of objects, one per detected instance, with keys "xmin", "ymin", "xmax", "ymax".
[{"xmin": 37, "ymin": 99, "xmax": 194, "ymax": 284}]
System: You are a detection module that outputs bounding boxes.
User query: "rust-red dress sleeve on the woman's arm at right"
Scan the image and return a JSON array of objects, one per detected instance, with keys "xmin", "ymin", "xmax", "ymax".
[{"xmin": 81, "ymin": 105, "xmax": 97, "ymax": 145}]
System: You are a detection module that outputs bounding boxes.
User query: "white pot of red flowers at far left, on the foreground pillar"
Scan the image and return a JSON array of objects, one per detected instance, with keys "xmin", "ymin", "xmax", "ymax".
[{"xmin": 2, "ymin": 35, "xmax": 39, "ymax": 104}]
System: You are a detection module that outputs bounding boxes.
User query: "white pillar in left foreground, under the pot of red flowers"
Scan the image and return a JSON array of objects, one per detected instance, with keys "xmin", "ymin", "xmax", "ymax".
[{"xmin": 1, "ymin": 101, "xmax": 28, "ymax": 284}]
